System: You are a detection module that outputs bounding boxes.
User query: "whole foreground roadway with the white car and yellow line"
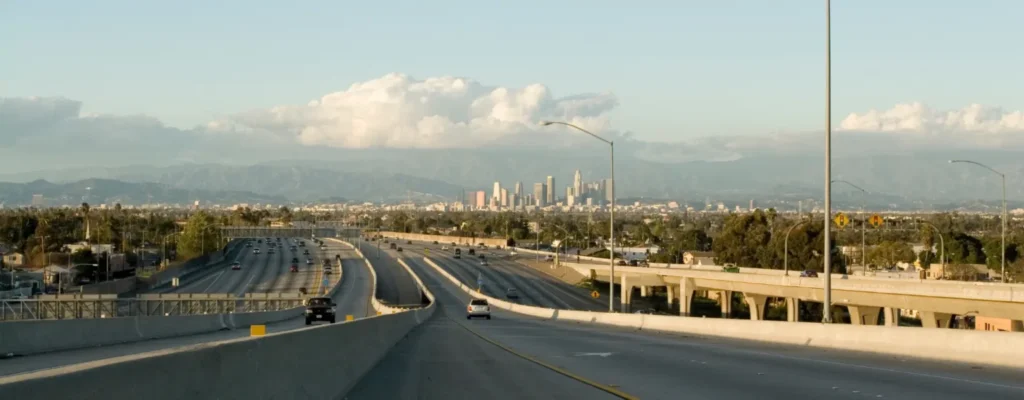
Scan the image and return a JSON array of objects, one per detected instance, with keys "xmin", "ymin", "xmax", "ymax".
[{"xmin": 346, "ymin": 252, "xmax": 1024, "ymax": 400}]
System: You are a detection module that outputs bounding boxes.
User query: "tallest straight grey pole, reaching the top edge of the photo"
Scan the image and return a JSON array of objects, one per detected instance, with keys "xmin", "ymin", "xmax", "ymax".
[{"xmin": 821, "ymin": 0, "xmax": 831, "ymax": 323}]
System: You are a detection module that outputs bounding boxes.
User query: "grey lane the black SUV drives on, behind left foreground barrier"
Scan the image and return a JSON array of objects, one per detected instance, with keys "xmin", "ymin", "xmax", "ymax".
[{"xmin": 0, "ymin": 250, "xmax": 375, "ymax": 375}]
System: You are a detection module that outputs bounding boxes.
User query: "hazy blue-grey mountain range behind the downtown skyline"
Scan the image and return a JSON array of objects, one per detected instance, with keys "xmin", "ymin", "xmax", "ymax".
[{"xmin": 0, "ymin": 148, "xmax": 1024, "ymax": 209}]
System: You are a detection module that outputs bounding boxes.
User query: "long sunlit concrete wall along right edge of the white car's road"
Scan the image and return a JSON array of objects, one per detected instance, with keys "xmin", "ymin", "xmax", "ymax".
[{"xmin": 424, "ymin": 258, "xmax": 1024, "ymax": 368}]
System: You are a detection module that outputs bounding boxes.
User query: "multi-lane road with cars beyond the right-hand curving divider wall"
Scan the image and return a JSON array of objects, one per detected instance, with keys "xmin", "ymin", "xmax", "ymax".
[{"xmin": 395, "ymin": 241, "xmax": 608, "ymax": 311}]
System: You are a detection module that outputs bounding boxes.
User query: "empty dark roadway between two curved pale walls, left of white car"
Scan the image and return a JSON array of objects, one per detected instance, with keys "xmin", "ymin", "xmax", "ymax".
[{"xmin": 349, "ymin": 239, "xmax": 423, "ymax": 306}]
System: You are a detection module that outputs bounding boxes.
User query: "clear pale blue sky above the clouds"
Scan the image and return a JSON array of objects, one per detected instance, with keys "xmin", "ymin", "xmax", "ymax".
[{"xmin": 0, "ymin": 0, "xmax": 1024, "ymax": 141}]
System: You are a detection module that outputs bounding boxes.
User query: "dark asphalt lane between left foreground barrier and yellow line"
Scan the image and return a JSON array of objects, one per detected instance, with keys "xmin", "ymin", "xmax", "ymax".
[{"xmin": 344, "ymin": 258, "xmax": 615, "ymax": 400}]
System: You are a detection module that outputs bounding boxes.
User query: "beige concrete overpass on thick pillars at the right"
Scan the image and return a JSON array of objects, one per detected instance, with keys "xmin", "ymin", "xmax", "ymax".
[{"xmin": 561, "ymin": 262, "xmax": 1024, "ymax": 331}]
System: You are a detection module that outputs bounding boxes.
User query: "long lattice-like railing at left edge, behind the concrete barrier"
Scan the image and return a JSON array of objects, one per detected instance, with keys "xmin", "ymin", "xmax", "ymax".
[{"xmin": 0, "ymin": 294, "xmax": 305, "ymax": 321}]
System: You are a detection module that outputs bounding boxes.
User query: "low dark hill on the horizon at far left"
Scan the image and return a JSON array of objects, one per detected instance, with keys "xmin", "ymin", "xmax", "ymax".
[{"xmin": 0, "ymin": 179, "xmax": 287, "ymax": 207}]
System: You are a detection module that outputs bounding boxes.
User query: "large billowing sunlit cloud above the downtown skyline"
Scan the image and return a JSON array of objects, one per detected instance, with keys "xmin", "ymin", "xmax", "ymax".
[{"xmin": 207, "ymin": 74, "xmax": 618, "ymax": 148}]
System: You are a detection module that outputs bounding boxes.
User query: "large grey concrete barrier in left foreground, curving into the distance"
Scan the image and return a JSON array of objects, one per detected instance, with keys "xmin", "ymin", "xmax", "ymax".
[{"xmin": 0, "ymin": 244, "xmax": 436, "ymax": 400}]
